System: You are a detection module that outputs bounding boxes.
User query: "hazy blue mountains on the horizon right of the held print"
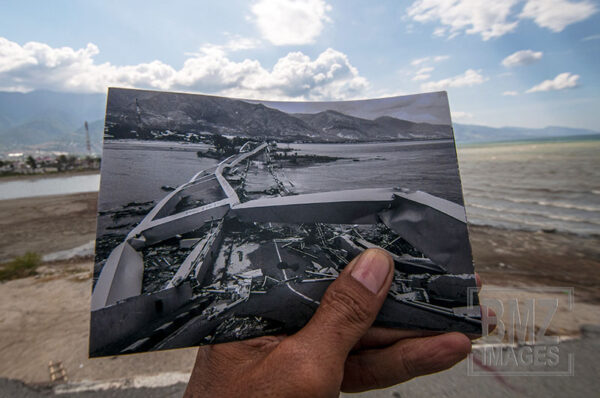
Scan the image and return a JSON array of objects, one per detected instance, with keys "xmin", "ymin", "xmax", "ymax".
[{"xmin": 454, "ymin": 123, "xmax": 600, "ymax": 144}]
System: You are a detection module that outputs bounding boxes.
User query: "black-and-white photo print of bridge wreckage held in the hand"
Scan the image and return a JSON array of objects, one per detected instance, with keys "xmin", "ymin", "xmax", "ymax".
[{"xmin": 90, "ymin": 88, "xmax": 481, "ymax": 357}]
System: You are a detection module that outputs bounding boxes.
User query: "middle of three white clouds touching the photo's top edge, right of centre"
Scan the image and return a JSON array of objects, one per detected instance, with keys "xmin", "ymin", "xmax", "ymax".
[{"xmin": 407, "ymin": 0, "xmax": 520, "ymax": 40}]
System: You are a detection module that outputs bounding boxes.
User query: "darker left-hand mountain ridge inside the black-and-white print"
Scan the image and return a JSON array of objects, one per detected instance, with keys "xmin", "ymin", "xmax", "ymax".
[{"xmin": 106, "ymin": 89, "xmax": 311, "ymax": 139}]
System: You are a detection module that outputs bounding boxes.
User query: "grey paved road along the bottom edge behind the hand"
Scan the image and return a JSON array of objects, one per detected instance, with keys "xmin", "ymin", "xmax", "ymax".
[{"xmin": 0, "ymin": 327, "xmax": 600, "ymax": 398}]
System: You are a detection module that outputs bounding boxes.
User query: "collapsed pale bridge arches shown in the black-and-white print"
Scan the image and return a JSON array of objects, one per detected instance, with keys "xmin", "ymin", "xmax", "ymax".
[{"xmin": 92, "ymin": 143, "xmax": 482, "ymax": 354}]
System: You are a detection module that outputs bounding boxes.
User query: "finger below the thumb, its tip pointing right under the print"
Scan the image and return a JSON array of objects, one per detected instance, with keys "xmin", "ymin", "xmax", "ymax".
[{"xmin": 342, "ymin": 333, "xmax": 471, "ymax": 392}]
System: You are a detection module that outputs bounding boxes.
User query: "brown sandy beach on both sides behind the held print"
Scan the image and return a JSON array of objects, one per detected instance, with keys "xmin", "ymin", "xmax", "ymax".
[{"xmin": 0, "ymin": 193, "xmax": 600, "ymax": 383}]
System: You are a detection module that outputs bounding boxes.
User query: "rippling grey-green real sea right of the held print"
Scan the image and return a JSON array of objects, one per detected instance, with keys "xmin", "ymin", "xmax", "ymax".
[{"xmin": 458, "ymin": 140, "xmax": 600, "ymax": 236}]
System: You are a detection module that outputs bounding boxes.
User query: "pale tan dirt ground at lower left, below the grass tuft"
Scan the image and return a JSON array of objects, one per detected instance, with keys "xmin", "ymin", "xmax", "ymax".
[{"xmin": 0, "ymin": 259, "xmax": 196, "ymax": 383}]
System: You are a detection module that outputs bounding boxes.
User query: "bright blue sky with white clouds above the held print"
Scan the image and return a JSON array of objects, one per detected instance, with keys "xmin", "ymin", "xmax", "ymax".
[{"xmin": 0, "ymin": 0, "xmax": 600, "ymax": 130}]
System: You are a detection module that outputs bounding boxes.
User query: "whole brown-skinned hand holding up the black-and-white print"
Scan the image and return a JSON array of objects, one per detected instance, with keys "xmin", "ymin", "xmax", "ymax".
[{"xmin": 185, "ymin": 249, "xmax": 471, "ymax": 398}]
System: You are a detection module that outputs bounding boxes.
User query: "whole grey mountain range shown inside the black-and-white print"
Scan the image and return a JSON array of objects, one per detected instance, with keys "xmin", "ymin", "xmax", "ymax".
[{"xmin": 106, "ymin": 89, "xmax": 452, "ymax": 142}]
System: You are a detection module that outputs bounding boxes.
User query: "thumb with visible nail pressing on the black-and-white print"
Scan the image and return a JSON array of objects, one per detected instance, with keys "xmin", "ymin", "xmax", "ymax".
[{"xmin": 293, "ymin": 249, "xmax": 394, "ymax": 364}]
